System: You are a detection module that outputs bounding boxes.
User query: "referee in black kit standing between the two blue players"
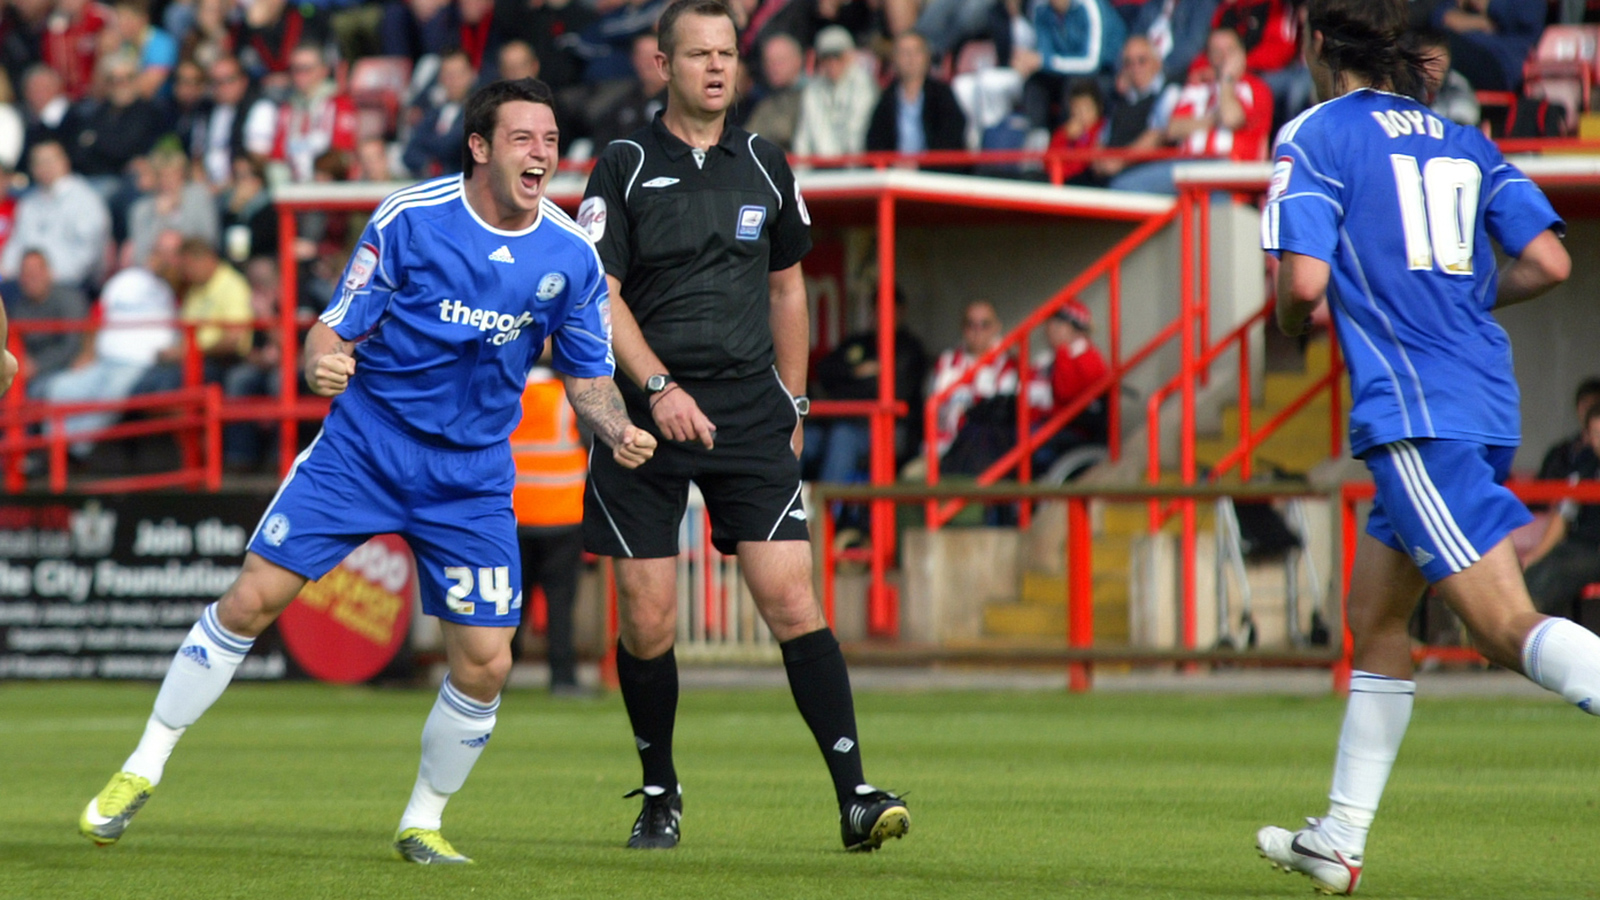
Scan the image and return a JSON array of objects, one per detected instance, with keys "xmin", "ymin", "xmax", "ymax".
[{"xmin": 579, "ymin": 0, "xmax": 910, "ymax": 850}]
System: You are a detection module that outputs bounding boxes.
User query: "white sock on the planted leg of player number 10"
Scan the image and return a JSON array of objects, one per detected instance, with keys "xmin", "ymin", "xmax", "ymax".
[{"xmin": 1322, "ymin": 669, "xmax": 1416, "ymax": 855}]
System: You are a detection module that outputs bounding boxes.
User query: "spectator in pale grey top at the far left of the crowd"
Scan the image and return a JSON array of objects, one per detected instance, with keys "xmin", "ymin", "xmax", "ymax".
[{"xmin": 0, "ymin": 139, "xmax": 110, "ymax": 285}]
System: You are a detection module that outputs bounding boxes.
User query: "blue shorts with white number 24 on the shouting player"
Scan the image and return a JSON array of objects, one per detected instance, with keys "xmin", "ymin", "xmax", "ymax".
[{"xmin": 250, "ymin": 399, "xmax": 522, "ymax": 626}]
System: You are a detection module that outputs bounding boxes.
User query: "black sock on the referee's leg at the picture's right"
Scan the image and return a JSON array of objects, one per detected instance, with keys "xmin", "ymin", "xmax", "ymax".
[{"xmin": 779, "ymin": 628, "xmax": 866, "ymax": 806}]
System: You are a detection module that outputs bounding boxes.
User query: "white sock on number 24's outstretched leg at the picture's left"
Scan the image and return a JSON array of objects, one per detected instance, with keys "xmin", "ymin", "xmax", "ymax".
[{"xmin": 122, "ymin": 604, "xmax": 256, "ymax": 785}]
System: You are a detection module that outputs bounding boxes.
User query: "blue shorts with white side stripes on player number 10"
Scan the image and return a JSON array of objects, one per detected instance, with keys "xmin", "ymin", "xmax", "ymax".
[{"xmin": 1363, "ymin": 439, "xmax": 1533, "ymax": 585}]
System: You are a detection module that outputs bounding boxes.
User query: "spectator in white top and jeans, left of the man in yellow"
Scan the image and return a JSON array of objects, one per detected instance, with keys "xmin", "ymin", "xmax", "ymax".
[{"xmin": 38, "ymin": 231, "xmax": 184, "ymax": 460}]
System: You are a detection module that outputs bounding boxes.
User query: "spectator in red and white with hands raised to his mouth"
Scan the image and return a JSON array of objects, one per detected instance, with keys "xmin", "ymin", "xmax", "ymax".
[{"xmin": 1110, "ymin": 29, "xmax": 1272, "ymax": 194}]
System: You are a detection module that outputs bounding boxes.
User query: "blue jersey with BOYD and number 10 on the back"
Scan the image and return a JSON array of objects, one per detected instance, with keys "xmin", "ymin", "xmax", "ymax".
[{"xmin": 1261, "ymin": 90, "xmax": 1565, "ymax": 455}]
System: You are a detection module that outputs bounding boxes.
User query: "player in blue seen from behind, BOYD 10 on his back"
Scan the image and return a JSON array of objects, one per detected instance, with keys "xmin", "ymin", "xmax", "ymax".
[{"xmin": 1256, "ymin": 0, "xmax": 1600, "ymax": 894}]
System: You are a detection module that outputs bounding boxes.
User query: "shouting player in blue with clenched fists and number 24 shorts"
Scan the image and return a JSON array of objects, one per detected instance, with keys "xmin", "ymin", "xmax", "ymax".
[{"xmin": 78, "ymin": 78, "xmax": 656, "ymax": 863}]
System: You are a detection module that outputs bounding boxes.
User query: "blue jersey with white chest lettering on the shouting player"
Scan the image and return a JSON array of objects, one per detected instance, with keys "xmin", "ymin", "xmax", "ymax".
[{"xmin": 322, "ymin": 175, "xmax": 614, "ymax": 447}]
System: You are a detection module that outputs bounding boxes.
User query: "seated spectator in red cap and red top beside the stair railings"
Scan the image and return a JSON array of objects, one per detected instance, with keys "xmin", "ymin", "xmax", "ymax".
[{"xmin": 1029, "ymin": 299, "xmax": 1109, "ymax": 468}]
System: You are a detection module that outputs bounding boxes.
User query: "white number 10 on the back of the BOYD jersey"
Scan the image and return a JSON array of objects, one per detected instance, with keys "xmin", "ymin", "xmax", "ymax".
[{"xmin": 1389, "ymin": 154, "xmax": 1483, "ymax": 275}]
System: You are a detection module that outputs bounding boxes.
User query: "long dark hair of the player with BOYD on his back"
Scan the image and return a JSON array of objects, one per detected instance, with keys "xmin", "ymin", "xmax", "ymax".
[{"xmin": 1306, "ymin": 0, "xmax": 1429, "ymax": 96}]
